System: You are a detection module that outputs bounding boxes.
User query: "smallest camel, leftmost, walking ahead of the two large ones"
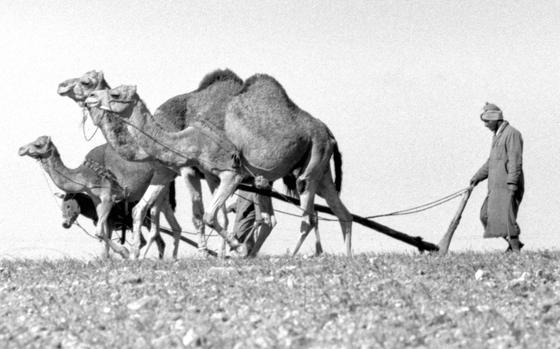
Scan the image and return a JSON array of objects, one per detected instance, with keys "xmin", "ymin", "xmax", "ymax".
[{"xmin": 19, "ymin": 136, "xmax": 181, "ymax": 258}]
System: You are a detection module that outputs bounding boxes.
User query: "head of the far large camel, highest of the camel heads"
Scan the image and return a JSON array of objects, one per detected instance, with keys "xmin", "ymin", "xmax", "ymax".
[{"xmin": 57, "ymin": 70, "xmax": 109, "ymax": 107}]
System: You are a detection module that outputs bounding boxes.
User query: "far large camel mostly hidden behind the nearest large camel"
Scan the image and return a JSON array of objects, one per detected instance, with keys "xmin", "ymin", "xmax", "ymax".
[{"xmin": 58, "ymin": 69, "xmax": 243, "ymax": 254}]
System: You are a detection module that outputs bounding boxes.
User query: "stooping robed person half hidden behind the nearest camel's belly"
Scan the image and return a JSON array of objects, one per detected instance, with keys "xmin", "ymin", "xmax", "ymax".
[{"xmin": 227, "ymin": 177, "xmax": 276, "ymax": 257}]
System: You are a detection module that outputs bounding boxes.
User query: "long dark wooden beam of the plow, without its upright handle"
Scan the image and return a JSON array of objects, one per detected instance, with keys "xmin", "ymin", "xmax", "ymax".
[{"xmin": 238, "ymin": 184, "xmax": 439, "ymax": 252}]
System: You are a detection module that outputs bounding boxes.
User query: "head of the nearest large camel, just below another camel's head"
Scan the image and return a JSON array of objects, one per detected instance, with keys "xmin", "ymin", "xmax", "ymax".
[{"xmin": 85, "ymin": 85, "xmax": 140, "ymax": 117}]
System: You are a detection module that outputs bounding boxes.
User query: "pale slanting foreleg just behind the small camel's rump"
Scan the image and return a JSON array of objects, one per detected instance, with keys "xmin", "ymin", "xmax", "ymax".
[{"xmin": 131, "ymin": 180, "xmax": 166, "ymax": 259}]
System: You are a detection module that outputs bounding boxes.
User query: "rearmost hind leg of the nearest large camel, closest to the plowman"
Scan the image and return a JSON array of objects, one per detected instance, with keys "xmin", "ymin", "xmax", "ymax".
[{"xmin": 318, "ymin": 171, "xmax": 352, "ymax": 257}]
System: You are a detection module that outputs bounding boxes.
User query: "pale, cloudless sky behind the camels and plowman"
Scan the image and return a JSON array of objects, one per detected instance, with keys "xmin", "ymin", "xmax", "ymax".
[{"xmin": 0, "ymin": 0, "xmax": 560, "ymax": 259}]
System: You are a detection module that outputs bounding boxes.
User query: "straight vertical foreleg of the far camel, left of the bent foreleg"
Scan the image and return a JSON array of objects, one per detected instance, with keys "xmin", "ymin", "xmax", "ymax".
[{"xmin": 181, "ymin": 167, "xmax": 207, "ymax": 253}]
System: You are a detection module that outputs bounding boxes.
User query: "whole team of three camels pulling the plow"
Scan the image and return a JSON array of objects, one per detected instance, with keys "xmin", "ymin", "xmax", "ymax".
[{"xmin": 19, "ymin": 69, "xmax": 352, "ymax": 259}]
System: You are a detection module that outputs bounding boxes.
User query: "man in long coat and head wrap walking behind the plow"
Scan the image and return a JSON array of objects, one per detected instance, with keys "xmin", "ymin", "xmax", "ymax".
[{"xmin": 470, "ymin": 102, "xmax": 525, "ymax": 252}]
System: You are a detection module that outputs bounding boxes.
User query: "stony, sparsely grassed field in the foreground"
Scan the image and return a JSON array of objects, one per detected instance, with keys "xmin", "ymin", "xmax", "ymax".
[{"xmin": 0, "ymin": 251, "xmax": 560, "ymax": 348}]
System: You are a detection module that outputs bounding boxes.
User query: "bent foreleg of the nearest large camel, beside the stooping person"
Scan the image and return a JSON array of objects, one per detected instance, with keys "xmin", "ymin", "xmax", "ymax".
[{"xmin": 204, "ymin": 171, "xmax": 247, "ymax": 255}]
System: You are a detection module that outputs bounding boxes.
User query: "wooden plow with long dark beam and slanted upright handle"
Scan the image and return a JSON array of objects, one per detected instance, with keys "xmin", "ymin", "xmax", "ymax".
[{"xmin": 237, "ymin": 184, "xmax": 473, "ymax": 254}]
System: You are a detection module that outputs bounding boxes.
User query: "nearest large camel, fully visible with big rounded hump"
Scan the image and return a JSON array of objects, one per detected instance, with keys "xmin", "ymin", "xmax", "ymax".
[{"xmin": 85, "ymin": 74, "xmax": 352, "ymax": 256}]
